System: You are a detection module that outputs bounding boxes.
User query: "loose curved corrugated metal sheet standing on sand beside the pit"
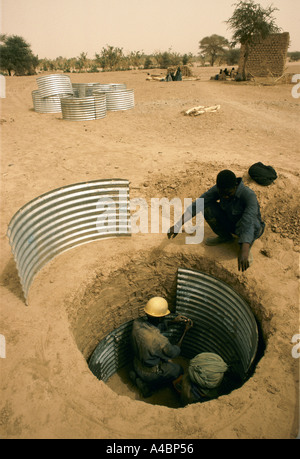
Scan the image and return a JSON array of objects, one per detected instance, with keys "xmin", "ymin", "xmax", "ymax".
[{"xmin": 7, "ymin": 179, "xmax": 131, "ymax": 300}]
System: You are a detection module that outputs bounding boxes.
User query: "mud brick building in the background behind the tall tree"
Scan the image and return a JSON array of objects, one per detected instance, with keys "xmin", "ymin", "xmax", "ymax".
[{"xmin": 239, "ymin": 32, "xmax": 290, "ymax": 77}]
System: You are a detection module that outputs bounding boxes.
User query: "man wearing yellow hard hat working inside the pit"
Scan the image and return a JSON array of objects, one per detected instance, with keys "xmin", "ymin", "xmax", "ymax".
[{"xmin": 130, "ymin": 297, "xmax": 193, "ymax": 398}]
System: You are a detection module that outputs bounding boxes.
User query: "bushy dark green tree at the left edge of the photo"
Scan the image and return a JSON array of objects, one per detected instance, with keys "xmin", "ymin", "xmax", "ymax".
[{"xmin": 0, "ymin": 35, "xmax": 39, "ymax": 75}]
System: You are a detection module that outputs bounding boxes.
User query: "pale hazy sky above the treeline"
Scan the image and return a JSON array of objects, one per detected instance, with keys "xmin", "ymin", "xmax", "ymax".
[{"xmin": 0, "ymin": 0, "xmax": 300, "ymax": 59}]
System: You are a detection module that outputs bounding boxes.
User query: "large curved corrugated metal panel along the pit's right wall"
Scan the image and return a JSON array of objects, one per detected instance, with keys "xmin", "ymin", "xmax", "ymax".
[{"xmin": 176, "ymin": 268, "xmax": 258, "ymax": 379}]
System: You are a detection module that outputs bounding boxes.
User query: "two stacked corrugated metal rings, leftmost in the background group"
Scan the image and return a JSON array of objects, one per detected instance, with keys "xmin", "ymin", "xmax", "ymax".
[{"xmin": 32, "ymin": 74, "xmax": 73, "ymax": 113}]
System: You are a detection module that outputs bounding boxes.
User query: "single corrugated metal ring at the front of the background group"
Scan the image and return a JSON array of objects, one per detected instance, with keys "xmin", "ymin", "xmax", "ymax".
[{"xmin": 61, "ymin": 93, "xmax": 106, "ymax": 121}]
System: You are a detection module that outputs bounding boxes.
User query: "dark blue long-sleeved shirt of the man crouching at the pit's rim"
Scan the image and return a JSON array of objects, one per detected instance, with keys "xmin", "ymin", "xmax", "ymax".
[{"xmin": 188, "ymin": 178, "xmax": 265, "ymax": 244}]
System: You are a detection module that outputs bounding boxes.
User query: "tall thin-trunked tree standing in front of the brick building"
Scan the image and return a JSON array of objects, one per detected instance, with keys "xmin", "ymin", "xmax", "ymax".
[{"xmin": 226, "ymin": 0, "xmax": 280, "ymax": 80}]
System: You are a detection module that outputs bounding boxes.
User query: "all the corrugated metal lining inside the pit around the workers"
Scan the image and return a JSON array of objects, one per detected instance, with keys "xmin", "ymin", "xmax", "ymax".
[{"xmin": 89, "ymin": 268, "xmax": 258, "ymax": 381}]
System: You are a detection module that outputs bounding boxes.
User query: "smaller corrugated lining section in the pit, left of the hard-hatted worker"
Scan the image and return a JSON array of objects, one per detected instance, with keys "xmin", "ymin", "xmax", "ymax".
[{"xmin": 88, "ymin": 314, "xmax": 182, "ymax": 382}]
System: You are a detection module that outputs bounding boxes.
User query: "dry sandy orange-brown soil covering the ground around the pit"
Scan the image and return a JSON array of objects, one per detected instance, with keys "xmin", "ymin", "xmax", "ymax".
[{"xmin": 0, "ymin": 65, "xmax": 300, "ymax": 439}]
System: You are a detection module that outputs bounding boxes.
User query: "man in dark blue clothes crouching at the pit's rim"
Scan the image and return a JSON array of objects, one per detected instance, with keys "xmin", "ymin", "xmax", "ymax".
[{"xmin": 168, "ymin": 169, "xmax": 265, "ymax": 271}]
